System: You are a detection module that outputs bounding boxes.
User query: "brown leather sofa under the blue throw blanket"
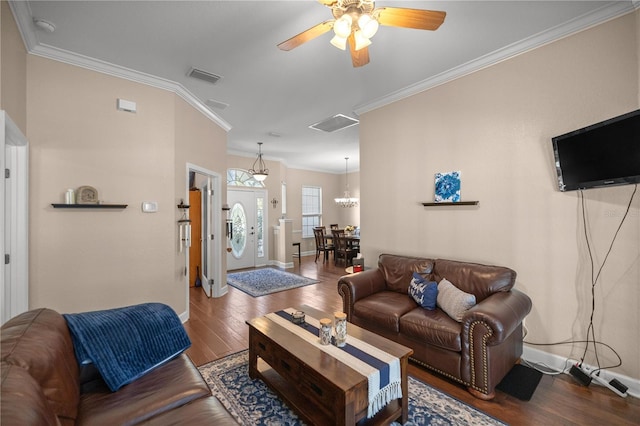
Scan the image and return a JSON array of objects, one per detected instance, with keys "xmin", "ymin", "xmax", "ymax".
[{"xmin": 0, "ymin": 309, "xmax": 238, "ymax": 426}]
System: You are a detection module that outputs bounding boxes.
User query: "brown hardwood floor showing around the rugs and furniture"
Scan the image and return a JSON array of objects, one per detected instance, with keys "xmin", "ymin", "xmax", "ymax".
[{"xmin": 185, "ymin": 256, "xmax": 640, "ymax": 425}]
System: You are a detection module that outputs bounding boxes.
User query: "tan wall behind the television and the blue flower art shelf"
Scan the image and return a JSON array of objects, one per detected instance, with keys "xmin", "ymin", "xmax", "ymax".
[{"xmin": 360, "ymin": 12, "xmax": 640, "ymax": 378}]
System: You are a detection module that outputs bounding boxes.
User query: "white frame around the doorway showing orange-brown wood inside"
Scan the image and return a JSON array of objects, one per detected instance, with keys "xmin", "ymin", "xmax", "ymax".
[{"xmin": 185, "ymin": 163, "xmax": 228, "ymax": 318}]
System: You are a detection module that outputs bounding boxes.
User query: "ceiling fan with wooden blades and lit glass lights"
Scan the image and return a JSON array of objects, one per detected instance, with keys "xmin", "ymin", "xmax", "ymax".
[{"xmin": 278, "ymin": 0, "xmax": 447, "ymax": 67}]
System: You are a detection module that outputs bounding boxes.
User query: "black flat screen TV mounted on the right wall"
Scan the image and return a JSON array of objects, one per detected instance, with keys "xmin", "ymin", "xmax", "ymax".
[{"xmin": 551, "ymin": 110, "xmax": 640, "ymax": 191}]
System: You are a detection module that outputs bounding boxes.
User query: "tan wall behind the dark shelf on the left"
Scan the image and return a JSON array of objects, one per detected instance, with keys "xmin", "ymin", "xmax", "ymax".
[{"xmin": 27, "ymin": 55, "xmax": 226, "ymax": 313}]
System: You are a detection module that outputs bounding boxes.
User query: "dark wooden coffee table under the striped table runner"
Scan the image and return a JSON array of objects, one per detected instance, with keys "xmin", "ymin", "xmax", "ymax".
[{"xmin": 247, "ymin": 305, "xmax": 413, "ymax": 425}]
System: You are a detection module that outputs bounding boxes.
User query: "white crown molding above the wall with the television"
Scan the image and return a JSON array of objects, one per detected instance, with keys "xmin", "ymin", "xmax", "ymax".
[{"xmin": 353, "ymin": 0, "xmax": 640, "ymax": 115}]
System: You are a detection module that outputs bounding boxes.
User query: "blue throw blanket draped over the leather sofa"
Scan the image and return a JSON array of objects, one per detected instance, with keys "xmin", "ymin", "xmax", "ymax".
[{"xmin": 63, "ymin": 303, "xmax": 191, "ymax": 391}]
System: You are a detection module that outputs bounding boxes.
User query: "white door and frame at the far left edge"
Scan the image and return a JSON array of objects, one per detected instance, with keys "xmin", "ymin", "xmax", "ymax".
[{"xmin": 0, "ymin": 111, "xmax": 29, "ymax": 324}]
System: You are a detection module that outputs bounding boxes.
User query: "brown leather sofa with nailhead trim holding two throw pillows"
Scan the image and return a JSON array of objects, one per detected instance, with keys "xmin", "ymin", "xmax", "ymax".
[{"xmin": 338, "ymin": 254, "xmax": 531, "ymax": 399}]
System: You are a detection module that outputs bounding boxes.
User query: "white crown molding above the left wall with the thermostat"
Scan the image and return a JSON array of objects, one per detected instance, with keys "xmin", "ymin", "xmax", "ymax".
[{"xmin": 9, "ymin": 1, "xmax": 231, "ymax": 132}]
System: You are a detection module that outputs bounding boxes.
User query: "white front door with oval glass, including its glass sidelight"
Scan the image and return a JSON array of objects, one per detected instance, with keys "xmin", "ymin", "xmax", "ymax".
[{"xmin": 227, "ymin": 190, "xmax": 266, "ymax": 270}]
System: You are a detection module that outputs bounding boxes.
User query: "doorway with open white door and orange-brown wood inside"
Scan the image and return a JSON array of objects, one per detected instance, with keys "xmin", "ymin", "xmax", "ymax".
[{"xmin": 185, "ymin": 163, "xmax": 228, "ymax": 310}]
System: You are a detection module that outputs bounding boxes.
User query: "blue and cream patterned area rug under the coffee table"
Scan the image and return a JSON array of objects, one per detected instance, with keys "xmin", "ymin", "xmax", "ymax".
[{"xmin": 198, "ymin": 350, "xmax": 505, "ymax": 426}]
